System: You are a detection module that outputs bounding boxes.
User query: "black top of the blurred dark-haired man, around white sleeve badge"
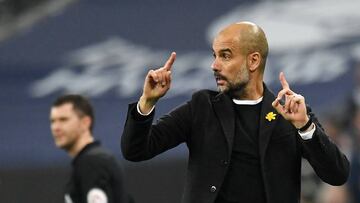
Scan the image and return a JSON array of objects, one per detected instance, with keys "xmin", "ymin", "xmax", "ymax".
[{"xmin": 66, "ymin": 141, "xmax": 129, "ymax": 203}]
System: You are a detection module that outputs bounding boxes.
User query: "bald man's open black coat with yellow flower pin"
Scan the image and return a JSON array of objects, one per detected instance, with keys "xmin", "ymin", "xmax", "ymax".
[{"xmin": 121, "ymin": 86, "xmax": 349, "ymax": 203}]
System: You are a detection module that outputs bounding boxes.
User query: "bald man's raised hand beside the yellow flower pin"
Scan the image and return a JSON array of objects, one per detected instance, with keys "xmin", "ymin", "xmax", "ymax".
[{"xmin": 272, "ymin": 72, "xmax": 309, "ymax": 129}]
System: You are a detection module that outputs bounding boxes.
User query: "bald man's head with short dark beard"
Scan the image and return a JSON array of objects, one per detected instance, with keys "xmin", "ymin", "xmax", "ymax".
[{"xmin": 212, "ymin": 22, "xmax": 268, "ymax": 97}]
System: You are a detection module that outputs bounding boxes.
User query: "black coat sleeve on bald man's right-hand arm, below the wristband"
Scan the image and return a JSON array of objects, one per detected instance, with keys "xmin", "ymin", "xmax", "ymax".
[{"xmin": 301, "ymin": 112, "xmax": 350, "ymax": 185}]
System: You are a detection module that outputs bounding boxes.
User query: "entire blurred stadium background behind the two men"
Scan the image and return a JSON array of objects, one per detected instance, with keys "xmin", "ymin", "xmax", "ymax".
[{"xmin": 0, "ymin": 0, "xmax": 360, "ymax": 203}]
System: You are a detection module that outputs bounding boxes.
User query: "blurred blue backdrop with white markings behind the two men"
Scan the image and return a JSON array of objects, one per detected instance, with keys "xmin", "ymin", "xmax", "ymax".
[{"xmin": 0, "ymin": 0, "xmax": 360, "ymax": 202}]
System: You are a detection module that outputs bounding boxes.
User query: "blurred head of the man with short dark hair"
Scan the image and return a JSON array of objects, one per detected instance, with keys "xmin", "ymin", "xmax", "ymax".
[{"xmin": 50, "ymin": 95, "xmax": 94, "ymax": 151}]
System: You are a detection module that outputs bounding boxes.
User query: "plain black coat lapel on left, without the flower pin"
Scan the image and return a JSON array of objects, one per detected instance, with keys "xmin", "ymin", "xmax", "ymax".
[{"xmin": 212, "ymin": 93, "xmax": 235, "ymax": 154}]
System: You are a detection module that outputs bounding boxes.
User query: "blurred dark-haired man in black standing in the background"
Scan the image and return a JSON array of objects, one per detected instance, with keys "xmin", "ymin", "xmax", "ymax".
[{"xmin": 50, "ymin": 95, "xmax": 128, "ymax": 203}]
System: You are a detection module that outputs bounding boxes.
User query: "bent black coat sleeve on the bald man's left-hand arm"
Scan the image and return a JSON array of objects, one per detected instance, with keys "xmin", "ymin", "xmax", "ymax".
[{"xmin": 121, "ymin": 103, "xmax": 191, "ymax": 161}]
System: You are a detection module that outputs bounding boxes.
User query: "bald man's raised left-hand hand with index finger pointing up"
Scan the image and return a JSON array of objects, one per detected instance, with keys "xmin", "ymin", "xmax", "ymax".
[{"xmin": 139, "ymin": 52, "xmax": 176, "ymax": 114}]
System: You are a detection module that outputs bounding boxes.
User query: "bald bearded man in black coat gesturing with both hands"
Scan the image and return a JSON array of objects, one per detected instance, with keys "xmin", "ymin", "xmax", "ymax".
[{"xmin": 121, "ymin": 22, "xmax": 349, "ymax": 203}]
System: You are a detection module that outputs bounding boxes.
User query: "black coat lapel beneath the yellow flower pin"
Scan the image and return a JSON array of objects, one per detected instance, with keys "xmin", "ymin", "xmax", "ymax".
[{"xmin": 259, "ymin": 84, "xmax": 280, "ymax": 163}]
